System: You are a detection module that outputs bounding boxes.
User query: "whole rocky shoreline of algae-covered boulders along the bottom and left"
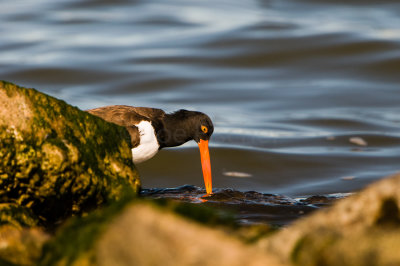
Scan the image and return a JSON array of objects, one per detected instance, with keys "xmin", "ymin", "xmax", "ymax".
[{"xmin": 0, "ymin": 81, "xmax": 400, "ymax": 265}]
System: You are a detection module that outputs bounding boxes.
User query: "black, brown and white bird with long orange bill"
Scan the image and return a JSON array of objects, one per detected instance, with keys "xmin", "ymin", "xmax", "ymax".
[{"xmin": 86, "ymin": 105, "xmax": 214, "ymax": 195}]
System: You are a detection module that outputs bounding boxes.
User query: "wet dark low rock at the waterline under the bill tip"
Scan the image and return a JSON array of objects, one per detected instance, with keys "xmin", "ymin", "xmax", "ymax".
[{"xmin": 140, "ymin": 185, "xmax": 330, "ymax": 226}]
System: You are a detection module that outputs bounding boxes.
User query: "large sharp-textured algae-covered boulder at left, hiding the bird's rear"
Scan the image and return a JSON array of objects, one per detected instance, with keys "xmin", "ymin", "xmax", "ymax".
[{"xmin": 0, "ymin": 81, "xmax": 140, "ymax": 225}]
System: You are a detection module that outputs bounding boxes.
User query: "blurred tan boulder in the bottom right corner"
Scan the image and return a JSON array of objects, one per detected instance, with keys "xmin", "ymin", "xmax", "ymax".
[{"xmin": 259, "ymin": 174, "xmax": 400, "ymax": 266}]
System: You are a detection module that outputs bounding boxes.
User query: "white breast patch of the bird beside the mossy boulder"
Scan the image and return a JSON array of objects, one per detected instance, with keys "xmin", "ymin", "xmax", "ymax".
[{"xmin": 132, "ymin": 121, "xmax": 160, "ymax": 163}]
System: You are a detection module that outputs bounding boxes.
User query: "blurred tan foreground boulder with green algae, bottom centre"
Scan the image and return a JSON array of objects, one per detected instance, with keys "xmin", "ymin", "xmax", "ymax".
[{"xmin": 39, "ymin": 201, "xmax": 282, "ymax": 266}]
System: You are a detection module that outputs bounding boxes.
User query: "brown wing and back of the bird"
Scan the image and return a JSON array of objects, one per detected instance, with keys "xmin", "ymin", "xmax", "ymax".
[{"xmin": 86, "ymin": 105, "xmax": 165, "ymax": 148}]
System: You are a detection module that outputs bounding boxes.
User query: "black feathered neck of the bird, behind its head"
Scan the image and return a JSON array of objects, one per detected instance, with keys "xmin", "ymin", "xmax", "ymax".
[{"xmin": 157, "ymin": 113, "xmax": 194, "ymax": 148}]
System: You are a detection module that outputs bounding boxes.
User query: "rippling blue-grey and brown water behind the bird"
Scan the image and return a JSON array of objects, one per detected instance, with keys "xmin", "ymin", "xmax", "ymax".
[{"xmin": 0, "ymin": 0, "xmax": 400, "ymax": 222}]
